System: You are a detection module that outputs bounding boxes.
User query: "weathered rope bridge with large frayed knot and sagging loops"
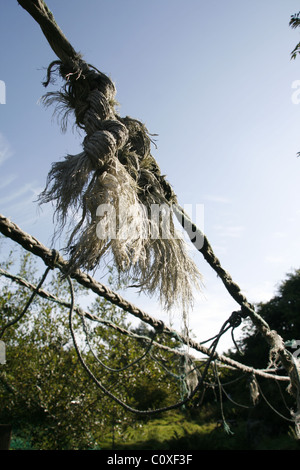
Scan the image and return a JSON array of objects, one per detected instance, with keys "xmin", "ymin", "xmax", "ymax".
[{"xmin": 0, "ymin": 0, "xmax": 300, "ymax": 438}]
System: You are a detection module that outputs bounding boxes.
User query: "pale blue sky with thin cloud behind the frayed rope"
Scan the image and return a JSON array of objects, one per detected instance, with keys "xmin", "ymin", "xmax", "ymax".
[{"xmin": 0, "ymin": 0, "xmax": 300, "ymax": 349}]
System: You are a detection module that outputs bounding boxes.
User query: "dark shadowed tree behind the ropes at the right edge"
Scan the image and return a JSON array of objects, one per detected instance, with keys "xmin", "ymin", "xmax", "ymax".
[{"xmin": 225, "ymin": 269, "xmax": 300, "ymax": 439}]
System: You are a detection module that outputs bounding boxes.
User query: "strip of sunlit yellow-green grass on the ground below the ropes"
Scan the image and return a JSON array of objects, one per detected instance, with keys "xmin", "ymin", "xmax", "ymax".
[{"xmin": 100, "ymin": 413, "xmax": 300, "ymax": 451}]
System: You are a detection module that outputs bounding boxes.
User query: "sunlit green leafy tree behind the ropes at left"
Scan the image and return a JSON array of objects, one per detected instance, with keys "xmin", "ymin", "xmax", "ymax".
[{"xmin": 0, "ymin": 244, "xmax": 180, "ymax": 449}]
